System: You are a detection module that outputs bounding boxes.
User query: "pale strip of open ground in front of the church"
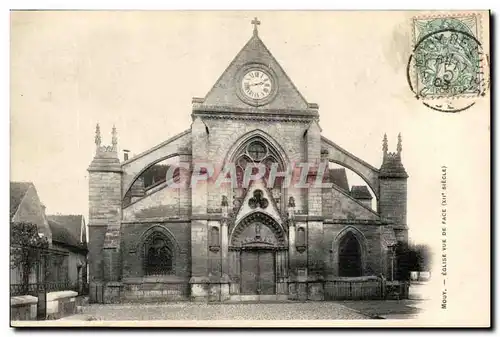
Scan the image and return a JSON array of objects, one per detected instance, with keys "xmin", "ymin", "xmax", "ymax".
[{"xmin": 57, "ymin": 283, "xmax": 427, "ymax": 321}]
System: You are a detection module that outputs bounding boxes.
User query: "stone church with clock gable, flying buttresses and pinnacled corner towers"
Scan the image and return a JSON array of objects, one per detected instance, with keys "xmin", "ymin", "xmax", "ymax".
[{"xmin": 88, "ymin": 19, "xmax": 408, "ymax": 303}]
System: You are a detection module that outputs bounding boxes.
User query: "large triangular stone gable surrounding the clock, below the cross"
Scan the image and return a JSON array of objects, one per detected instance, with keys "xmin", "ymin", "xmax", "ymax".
[{"xmin": 198, "ymin": 34, "xmax": 317, "ymax": 110}]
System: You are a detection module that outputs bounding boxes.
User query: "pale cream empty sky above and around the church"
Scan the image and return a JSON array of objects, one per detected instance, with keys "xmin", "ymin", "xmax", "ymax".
[{"xmin": 10, "ymin": 11, "xmax": 490, "ymax": 242}]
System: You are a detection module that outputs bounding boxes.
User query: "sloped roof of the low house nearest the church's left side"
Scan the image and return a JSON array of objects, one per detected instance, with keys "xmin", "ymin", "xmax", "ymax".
[{"xmin": 47, "ymin": 214, "xmax": 86, "ymax": 246}]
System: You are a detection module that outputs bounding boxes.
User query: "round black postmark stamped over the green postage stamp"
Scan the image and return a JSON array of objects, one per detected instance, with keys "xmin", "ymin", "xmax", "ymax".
[{"xmin": 407, "ymin": 19, "xmax": 489, "ymax": 112}]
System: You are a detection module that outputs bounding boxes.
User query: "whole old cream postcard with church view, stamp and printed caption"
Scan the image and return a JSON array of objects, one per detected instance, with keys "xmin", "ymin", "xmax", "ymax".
[{"xmin": 9, "ymin": 10, "xmax": 491, "ymax": 328}]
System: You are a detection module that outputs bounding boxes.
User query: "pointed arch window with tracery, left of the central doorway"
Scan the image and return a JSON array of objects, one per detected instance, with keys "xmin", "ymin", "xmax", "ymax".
[{"xmin": 144, "ymin": 232, "xmax": 174, "ymax": 276}]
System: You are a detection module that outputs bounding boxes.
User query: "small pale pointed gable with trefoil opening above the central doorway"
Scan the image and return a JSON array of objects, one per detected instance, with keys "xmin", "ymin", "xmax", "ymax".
[{"xmin": 236, "ymin": 179, "xmax": 281, "ymax": 224}]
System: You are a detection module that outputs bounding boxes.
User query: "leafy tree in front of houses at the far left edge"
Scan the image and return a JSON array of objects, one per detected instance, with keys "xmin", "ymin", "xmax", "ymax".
[{"xmin": 10, "ymin": 222, "xmax": 49, "ymax": 293}]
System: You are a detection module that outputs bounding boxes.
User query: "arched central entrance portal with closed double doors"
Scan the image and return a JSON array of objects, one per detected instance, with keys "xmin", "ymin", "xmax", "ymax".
[{"xmin": 229, "ymin": 212, "xmax": 288, "ymax": 295}]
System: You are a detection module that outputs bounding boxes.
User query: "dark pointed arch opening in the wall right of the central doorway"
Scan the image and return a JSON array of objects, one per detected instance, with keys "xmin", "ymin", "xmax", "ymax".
[{"xmin": 339, "ymin": 232, "xmax": 362, "ymax": 277}]
